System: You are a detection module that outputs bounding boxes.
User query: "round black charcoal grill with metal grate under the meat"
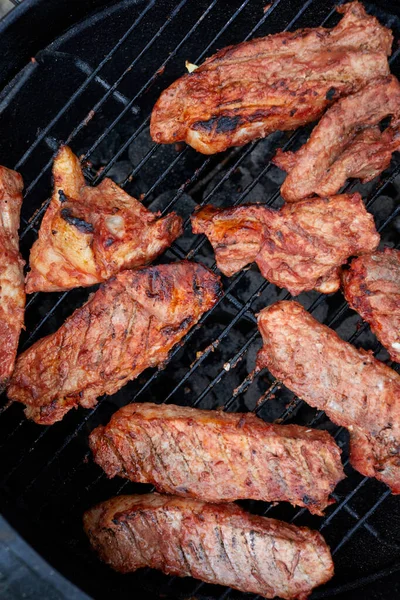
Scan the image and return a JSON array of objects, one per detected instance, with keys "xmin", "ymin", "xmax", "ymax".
[{"xmin": 0, "ymin": 0, "xmax": 400, "ymax": 600}]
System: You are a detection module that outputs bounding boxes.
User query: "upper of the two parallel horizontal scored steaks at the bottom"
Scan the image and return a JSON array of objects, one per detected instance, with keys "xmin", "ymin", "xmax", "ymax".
[{"xmin": 89, "ymin": 403, "xmax": 344, "ymax": 514}]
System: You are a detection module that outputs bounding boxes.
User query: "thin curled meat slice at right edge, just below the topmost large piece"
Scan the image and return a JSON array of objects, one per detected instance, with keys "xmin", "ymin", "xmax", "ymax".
[{"xmin": 273, "ymin": 76, "xmax": 400, "ymax": 202}]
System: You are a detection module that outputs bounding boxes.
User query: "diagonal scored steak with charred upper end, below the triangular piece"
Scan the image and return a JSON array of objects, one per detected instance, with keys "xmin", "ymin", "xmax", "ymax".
[{"xmin": 8, "ymin": 261, "xmax": 220, "ymax": 425}]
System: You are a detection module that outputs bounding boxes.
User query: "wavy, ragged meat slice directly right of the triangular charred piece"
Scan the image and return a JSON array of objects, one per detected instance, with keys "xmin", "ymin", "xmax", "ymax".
[{"xmin": 192, "ymin": 193, "xmax": 379, "ymax": 296}]
